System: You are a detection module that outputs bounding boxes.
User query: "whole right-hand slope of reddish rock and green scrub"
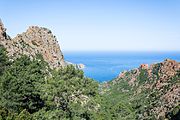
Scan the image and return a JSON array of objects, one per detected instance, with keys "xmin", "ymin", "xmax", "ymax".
[{"xmin": 102, "ymin": 59, "xmax": 180, "ymax": 120}]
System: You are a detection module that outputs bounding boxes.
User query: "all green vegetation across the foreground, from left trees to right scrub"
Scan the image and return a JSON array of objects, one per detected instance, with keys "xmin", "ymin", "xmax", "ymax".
[{"xmin": 0, "ymin": 46, "xmax": 179, "ymax": 120}]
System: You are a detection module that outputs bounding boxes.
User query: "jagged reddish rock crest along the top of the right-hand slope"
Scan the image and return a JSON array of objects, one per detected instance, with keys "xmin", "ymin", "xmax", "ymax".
[{"xmin": 117, "ymin": 59, "xmax": 180, "ymax": 88}]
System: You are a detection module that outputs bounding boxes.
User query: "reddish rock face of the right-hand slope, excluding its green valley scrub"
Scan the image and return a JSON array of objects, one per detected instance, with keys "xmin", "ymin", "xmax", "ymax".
[{"xmin": 114, "ymin": 59, "xmax": 180, "ymax": 119}]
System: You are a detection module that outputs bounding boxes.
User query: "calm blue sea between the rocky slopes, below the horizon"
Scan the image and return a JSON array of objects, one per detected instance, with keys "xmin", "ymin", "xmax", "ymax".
[{"xmin": 64, "ymin": 52, "xmax": 180, "ymax": 82}]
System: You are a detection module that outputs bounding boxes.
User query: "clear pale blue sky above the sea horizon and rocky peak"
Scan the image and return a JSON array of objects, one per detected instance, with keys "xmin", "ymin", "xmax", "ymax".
[{"xmin": 0, "ymin": 0, "xmax": 180, "ymax": 51}]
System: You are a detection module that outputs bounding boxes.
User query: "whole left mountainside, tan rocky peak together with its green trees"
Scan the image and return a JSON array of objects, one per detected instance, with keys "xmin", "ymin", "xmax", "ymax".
[{"xmin": 0, "ymin": 19, "xmax": 100, "ymax": 120}]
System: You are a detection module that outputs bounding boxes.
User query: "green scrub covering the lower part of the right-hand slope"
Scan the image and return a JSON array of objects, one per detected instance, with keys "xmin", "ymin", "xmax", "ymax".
[{"xmin": 101, "ymin": 69, "xmax": 180, "ymax": 120}]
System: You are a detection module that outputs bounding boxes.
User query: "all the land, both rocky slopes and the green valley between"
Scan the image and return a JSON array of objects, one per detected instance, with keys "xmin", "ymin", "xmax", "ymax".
[{"xmin": 0, "ymin": 21, "xmax": 180, "ymax": 120}]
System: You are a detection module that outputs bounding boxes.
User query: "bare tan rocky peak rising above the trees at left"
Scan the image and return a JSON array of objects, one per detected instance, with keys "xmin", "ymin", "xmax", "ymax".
[{"xmin": 0, "ymin": 22, "xmax": 66, "ymax": 68}]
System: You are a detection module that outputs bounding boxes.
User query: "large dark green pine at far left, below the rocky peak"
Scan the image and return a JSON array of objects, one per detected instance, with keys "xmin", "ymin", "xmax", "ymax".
[{"xmin": 0, "ymin": 56, "xmax": 45, "ymax": 113}]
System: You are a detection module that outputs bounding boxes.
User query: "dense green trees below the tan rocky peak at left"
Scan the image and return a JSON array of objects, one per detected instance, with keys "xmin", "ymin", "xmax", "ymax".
[{"xmin": 0, "ymin": 46, "xmax": 99, "ymax": 120}]
